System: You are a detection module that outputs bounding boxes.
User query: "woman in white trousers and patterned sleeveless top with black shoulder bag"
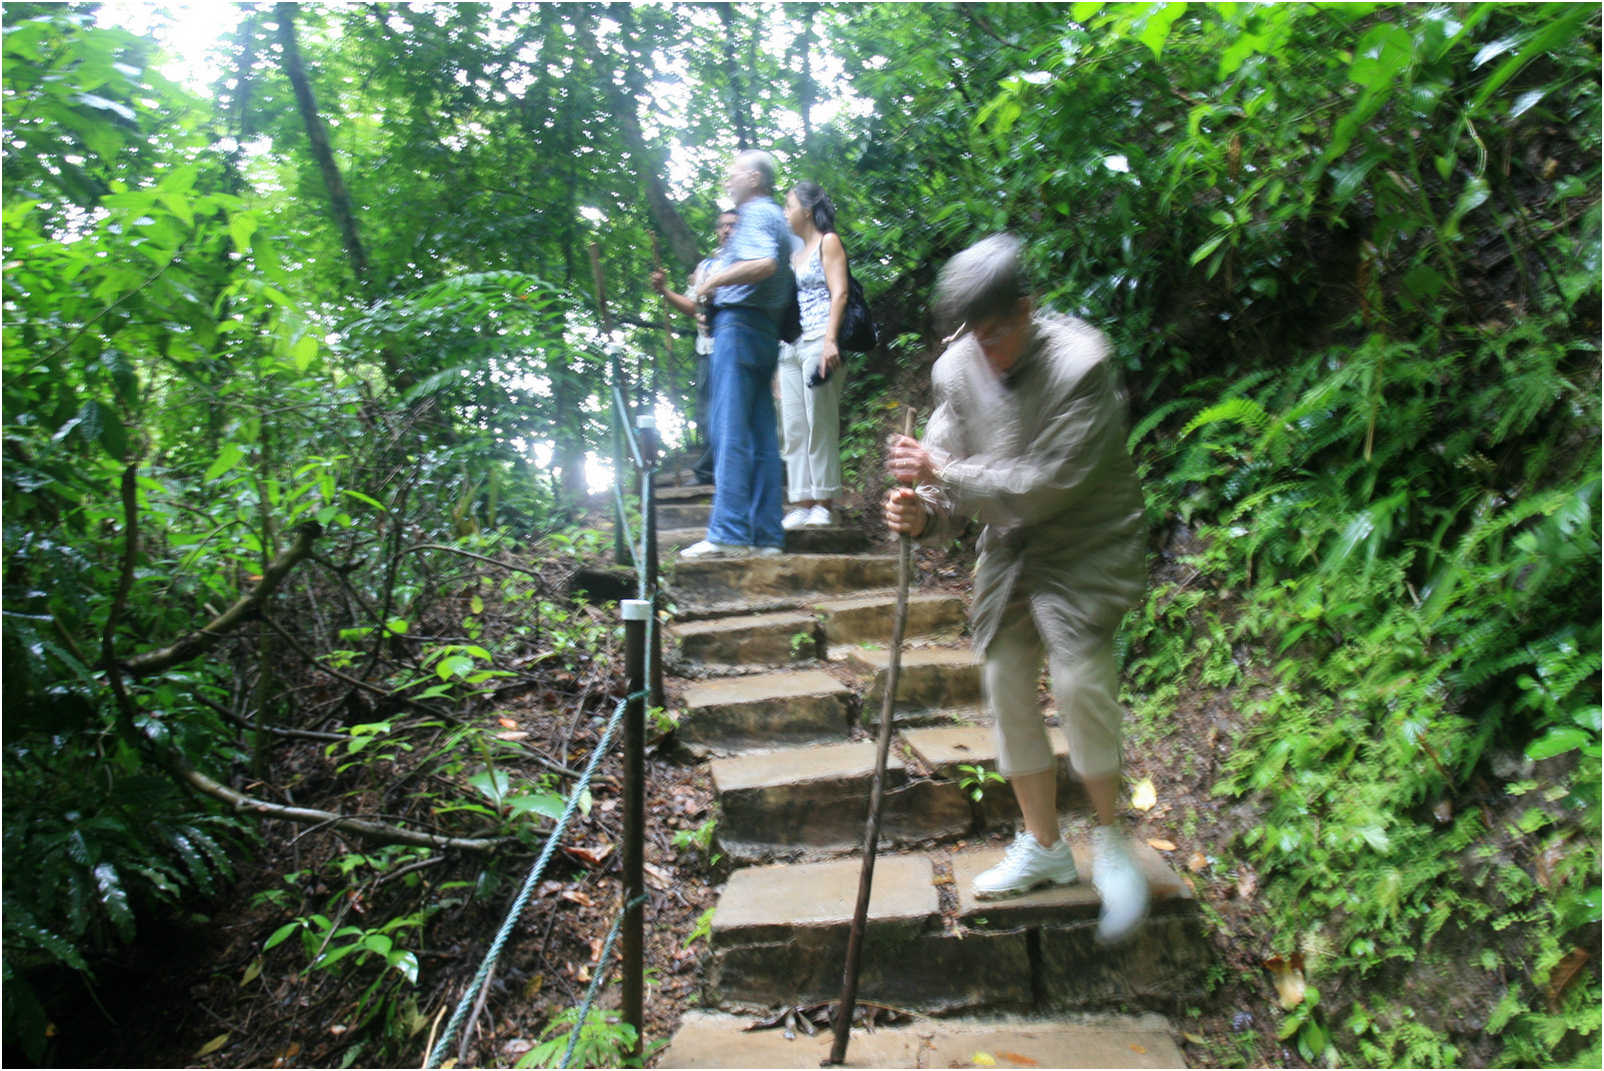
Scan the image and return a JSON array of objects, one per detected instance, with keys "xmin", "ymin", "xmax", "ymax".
[{"xmin": 780, "ymin": 183, "xmax": 847, "ymax": 529}]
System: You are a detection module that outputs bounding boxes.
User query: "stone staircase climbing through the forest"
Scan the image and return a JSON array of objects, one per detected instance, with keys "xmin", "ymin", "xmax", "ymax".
[{"xmin": 644, "ymin": 487, "xmax": 1206, "ymax": 1068}]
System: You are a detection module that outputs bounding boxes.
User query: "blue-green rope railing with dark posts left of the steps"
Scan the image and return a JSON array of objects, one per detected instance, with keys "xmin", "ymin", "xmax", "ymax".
[{"xmin": 423, "ymin": 354, "xmax": 662, "ymax": 1068}]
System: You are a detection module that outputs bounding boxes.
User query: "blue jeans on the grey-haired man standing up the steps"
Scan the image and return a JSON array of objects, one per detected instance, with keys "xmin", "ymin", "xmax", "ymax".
[{"xmin": 707, "ymin": 308, "xmax": 786, "ymax": 547}]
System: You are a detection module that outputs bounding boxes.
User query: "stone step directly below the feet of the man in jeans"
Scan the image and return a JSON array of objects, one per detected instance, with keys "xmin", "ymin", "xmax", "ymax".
[{"xmin": 664, "ymin": 555, "xmax": 897, "ymax": 611}]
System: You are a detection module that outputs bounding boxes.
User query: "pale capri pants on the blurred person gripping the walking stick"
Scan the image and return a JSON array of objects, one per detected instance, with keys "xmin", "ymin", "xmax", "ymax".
[{"xmin": 982, "ymin": 601, "xmax": 1124, "ymax": 778}]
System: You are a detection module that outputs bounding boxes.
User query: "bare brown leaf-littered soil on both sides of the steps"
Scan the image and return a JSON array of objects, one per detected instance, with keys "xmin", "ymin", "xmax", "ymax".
[{"xmin": 28, "ymin": 477, "xmax": 1552, "ymax": 1068}]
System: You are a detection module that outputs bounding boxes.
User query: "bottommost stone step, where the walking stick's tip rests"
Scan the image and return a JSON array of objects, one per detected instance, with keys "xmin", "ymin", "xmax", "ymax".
[{"xmin": 658, "ymin": 1010, "xmax": 1185, "ymax": 1068}]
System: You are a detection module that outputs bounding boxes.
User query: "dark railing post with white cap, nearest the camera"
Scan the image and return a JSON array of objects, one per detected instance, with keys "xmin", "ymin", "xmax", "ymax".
[{"xmin": 619, "ymin": 598, "xmax": 651, "ymax": 1057}]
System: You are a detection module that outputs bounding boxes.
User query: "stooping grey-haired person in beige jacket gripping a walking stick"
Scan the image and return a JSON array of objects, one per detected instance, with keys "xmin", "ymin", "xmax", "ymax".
[{"xmin": 884, "ymin": 234, "xmax": 1148, "ymax": 941}]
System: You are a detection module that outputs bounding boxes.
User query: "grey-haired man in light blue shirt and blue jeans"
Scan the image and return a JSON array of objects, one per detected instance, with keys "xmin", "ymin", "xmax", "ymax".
[{"xmin": 680, "ymin": 149, "xmax": 796, "ymax": 558}]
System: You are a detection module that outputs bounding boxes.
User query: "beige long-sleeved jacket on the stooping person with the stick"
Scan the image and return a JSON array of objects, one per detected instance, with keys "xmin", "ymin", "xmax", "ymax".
[{"xmin": 917, "ymin": 313, "xmax": 1145, "ymax": 654}]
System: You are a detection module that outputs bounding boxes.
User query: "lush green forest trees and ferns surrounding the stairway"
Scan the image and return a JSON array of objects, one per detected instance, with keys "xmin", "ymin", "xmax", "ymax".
[{"xmin": 0, "ymin": 3, "xmax": 1601, "ymax": 1066}]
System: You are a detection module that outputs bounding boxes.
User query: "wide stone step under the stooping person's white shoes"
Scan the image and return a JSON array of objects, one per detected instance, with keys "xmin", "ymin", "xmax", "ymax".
[{"xmin": 709, "ymin": 842, "xmax": 1209, "ymax": 1013}]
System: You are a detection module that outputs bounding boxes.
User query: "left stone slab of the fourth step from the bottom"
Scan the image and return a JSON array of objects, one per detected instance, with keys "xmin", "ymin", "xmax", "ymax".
[{"xmin": 678, "ymin": 670, "xmax": 852, "ymax": 749}]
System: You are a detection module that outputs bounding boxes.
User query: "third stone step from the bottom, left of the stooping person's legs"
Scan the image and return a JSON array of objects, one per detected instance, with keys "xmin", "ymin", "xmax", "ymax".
[{"xmin": 712, "ymin": 741, "xmax": 974, "ymax": 861}]
